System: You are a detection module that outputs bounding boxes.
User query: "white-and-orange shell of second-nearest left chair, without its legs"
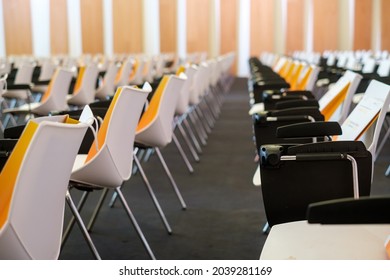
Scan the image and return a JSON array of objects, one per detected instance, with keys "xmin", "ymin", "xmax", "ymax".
[{"xmin": 71, "ymin": 84, "xmax": 151, "ymax": 188}]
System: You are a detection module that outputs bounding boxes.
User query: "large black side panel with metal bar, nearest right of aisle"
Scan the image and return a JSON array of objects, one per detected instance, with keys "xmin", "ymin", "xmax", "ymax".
[{"xmin": 260, "ymin": 141, "xmax": 372, "ymax": 227}]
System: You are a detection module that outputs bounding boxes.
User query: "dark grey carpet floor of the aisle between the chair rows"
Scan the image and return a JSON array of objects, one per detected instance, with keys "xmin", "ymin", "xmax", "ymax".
[{"xmin": 60, "ymin": 78, "xmax": 390, "ymax": 260}]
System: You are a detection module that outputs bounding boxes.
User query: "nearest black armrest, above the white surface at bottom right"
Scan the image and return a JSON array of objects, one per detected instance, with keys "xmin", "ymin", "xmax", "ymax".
[{"xmin": 307, "ymin": 196, "xmax": 390, "ymax": 224}]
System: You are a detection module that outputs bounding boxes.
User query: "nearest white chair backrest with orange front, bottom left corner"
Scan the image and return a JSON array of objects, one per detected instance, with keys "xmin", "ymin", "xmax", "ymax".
[{"xmin": 0, "ymin": 116, "xmax": 87, "ymax": 259}]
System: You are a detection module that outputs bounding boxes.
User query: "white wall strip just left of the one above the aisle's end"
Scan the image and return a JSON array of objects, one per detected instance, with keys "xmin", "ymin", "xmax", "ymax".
[{"xmin": 209, "ymin": 0, "xmax": 221, "ymax": 58}]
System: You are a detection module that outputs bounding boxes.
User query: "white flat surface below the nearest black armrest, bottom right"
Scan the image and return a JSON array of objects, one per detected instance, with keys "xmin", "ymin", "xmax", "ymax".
[{"xmin": 260, "ymin": 221, "xmax": 390, "ymax": 260}]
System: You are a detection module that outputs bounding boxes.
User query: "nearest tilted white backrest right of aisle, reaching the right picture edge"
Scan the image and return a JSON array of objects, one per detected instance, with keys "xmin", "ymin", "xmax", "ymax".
[{"xmin": 337, "ymin": 80, "xmax": 390, "ymax": 159}]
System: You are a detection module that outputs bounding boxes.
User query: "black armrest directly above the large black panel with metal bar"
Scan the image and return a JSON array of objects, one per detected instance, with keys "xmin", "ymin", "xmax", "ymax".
[{"xmin": 276, "ymin": 122, "xmax": 342, "ymax": 138}]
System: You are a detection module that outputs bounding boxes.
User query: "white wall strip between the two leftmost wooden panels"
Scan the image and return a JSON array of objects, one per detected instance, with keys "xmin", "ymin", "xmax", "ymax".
[{"xmin": 30, "ymin": 0, "xmax": 50, "ymax": 57}]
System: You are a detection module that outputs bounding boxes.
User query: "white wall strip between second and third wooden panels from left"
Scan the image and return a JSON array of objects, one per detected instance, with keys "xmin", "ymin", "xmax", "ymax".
[{"xmin": 67, "ymin": 0, "xmax": 83, "ymax": 57}]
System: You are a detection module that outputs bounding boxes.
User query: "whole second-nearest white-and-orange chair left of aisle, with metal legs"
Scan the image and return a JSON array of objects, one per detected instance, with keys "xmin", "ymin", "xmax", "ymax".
[{"xmin": 67, "ymin": 86, "xmax": 155, "ymax": 259}]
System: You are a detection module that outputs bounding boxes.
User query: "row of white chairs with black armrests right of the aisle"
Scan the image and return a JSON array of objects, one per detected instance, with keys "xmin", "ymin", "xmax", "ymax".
[{"xmin": 249, "ymin": 53, "xmax": 390, "ymax": 259}]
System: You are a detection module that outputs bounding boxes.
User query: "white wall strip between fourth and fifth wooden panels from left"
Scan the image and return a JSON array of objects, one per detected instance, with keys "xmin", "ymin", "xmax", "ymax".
[{"xmin": 142, "ymin": 0, "xmax": 160, "ymax": 55}]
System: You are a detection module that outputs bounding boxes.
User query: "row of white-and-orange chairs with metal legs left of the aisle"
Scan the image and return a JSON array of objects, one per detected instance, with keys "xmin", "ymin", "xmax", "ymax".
[{"xmin": 0, "ymin": 53, "xmax": 234, "ymax": 259}]
